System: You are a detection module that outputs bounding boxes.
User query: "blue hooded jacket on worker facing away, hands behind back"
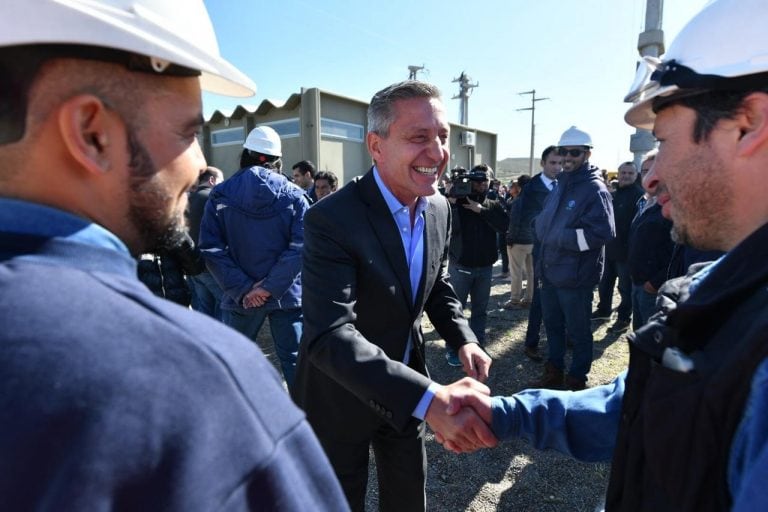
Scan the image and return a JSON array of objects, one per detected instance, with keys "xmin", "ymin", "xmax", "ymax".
[{"xmin": 200, "ymin": 167, "xmax": 309, "ymax": 312}]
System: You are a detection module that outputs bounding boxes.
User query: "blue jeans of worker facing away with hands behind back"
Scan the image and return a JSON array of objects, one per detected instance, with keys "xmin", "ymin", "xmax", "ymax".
[{"xmin": 224, "ymin": 308, "xmax": 304, "ymax": 389}]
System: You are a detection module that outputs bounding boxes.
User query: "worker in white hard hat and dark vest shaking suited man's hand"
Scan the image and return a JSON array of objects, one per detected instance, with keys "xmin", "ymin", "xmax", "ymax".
[{"xmin": 438, "ymin": 0, "xmax": 768, "ymax": 512}]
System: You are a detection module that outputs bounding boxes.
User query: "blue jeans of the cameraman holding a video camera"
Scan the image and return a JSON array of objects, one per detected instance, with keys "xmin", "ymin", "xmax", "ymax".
[{"xmin": 448, "ymin": 262, "xmax": 493, "ymax": 345}]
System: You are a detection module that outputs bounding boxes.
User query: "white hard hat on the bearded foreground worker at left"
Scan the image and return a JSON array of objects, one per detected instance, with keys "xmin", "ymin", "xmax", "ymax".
[{"xmin": 0, "ymin": 0, "xmax": 256, "ymax": 96}]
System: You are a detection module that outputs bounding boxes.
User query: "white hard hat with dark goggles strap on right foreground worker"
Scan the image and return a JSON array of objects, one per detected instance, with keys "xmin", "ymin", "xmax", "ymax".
[{"xmin": 624, "ymin": 0, "xmax": 768, "ymax": 129}]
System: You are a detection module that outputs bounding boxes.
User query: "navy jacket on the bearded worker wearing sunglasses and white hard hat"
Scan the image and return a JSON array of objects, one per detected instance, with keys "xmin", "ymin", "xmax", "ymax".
[{"xmin": 536, "ymin": 162, "xmax": 616, "ymax": 288}]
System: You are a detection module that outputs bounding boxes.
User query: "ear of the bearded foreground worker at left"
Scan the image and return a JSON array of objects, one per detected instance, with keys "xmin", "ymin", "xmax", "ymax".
[{"xmin": 58, "ymin": 94, "xmax": 120, "ymax": 174}]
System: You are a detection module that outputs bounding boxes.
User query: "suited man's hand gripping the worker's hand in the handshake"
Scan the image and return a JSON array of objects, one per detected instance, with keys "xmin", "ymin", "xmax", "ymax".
[{"xmin": 425, "ymin": 377, "xmax": 498, "ymax": 453}]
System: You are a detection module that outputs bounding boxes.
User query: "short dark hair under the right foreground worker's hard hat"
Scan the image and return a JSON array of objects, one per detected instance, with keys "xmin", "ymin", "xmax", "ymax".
[{"xmin": 653, "ymin": 85, "xmax": 768, "ymax": 144}]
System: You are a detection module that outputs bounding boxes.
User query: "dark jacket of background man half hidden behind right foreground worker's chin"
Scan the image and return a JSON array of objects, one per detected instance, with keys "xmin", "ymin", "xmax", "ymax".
[{"xmin": 627, "ymin": 204, "xmax": 674, "ymax": 290}]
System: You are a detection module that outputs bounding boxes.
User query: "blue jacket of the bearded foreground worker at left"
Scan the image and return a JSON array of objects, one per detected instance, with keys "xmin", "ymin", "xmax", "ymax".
[{"xmin": 0, "ymin": 199, "xmax": 348, "ymax": 511}]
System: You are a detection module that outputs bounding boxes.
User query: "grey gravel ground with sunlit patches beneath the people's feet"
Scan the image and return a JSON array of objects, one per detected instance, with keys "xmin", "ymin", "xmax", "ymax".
[{"xmin": 259, "ymin": 264, "xmax": 628, "ymax": 512}]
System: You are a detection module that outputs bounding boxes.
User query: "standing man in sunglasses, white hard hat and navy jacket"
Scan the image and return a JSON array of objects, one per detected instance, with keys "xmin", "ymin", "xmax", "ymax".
[{"xmin": 532, "ymin": 126, "xmax": 615, "ymax": 390}]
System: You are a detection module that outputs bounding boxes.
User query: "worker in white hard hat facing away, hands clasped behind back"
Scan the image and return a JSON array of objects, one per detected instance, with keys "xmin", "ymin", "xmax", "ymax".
[{"xmin": 200, "ymin": 126, "xmax": 309, "ymax": 387}]
